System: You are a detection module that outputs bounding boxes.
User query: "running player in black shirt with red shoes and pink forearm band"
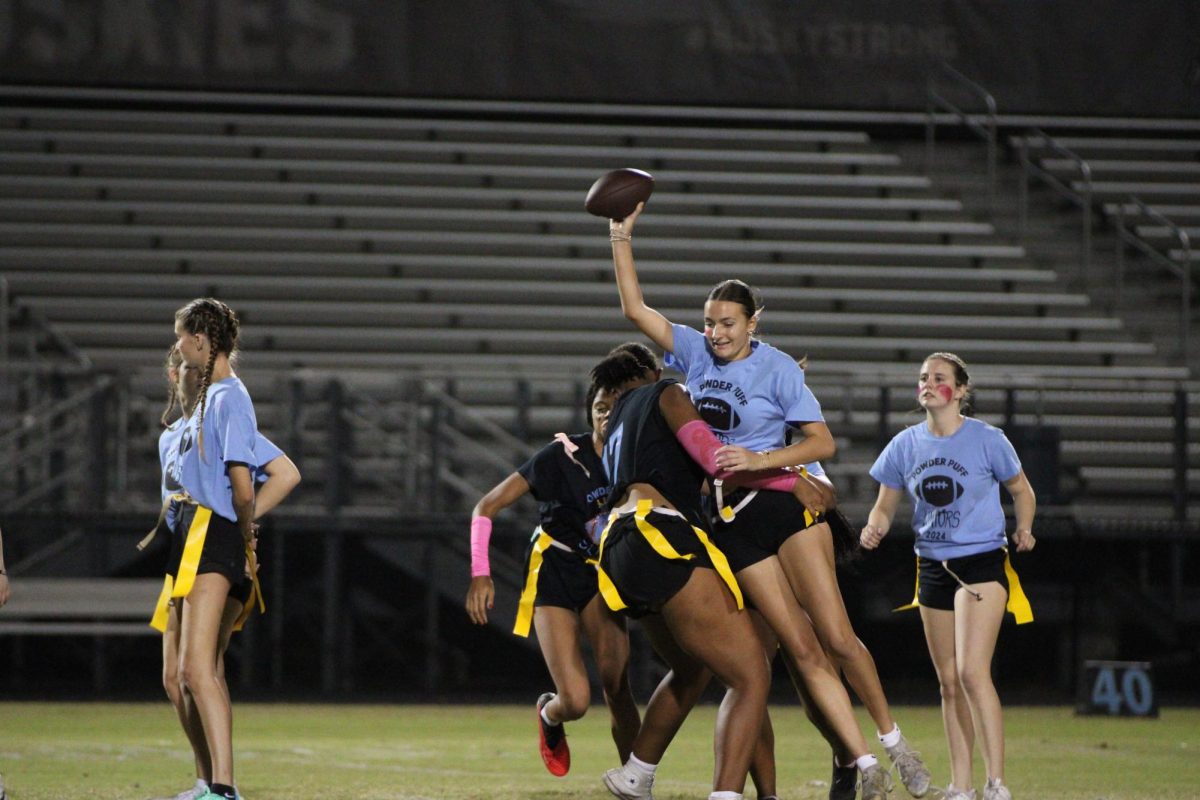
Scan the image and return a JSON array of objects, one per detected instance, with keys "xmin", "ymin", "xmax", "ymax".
[{"xmin": 466, "ymin": 345, "xmax": 654, "ymax": 777}]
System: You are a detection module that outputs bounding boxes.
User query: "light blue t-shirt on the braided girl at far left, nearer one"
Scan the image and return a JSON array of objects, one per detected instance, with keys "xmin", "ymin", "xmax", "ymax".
[{"xmin": 179, "ymin": 378, "xmax": 263, "ymax": 522}]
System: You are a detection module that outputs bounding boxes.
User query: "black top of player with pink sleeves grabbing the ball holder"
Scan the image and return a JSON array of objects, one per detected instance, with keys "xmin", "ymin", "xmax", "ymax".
[{"xmin": 604, "ymin": 379, "xmax": 708, "ymax": 530}]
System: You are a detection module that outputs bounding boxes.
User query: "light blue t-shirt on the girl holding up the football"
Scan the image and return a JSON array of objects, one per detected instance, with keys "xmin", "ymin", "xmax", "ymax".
[{"xmin": 666, "ymin": 325, "xmax": 824, "ymax": 450}]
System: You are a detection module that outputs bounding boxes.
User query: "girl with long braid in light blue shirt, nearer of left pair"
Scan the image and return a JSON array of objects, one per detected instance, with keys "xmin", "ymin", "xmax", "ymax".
[{"xmin": 172, "ymin": 297, "xmax": 260, "ymax": 800}]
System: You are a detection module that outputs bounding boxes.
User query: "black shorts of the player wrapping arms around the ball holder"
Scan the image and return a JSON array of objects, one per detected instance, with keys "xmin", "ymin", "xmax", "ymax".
[{"xmin": 600, "ymin": 510, "xmax": 713, "ymax": 619}]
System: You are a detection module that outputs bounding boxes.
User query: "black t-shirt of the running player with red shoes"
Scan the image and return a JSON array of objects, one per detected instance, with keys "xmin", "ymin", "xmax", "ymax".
[{"xmin": 517, "ymin": 433, "xmax": 608, "ymax": 557}]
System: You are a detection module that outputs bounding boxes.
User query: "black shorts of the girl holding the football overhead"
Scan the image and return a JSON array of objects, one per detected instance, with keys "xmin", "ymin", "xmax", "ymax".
[{"xmin": 713, "ymin": 489, "xmax": 824, "ymax": 573}]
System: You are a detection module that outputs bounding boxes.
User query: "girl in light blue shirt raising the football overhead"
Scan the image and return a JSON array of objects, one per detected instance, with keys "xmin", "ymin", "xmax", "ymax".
[{"xmin": 610, "ymin": 206, "xmax": 930, "ymax": 800}]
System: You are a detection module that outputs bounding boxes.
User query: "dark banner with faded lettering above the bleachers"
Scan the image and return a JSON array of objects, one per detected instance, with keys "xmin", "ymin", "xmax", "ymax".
[{"xmin": 0, "ymin": 0, "xmax": 1200, "ymax": 116}]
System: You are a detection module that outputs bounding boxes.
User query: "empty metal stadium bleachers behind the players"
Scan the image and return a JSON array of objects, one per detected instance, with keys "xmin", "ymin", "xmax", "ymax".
[{"xmin": 0, "ymin": 97, "xmax": 1194, "ymax": 525}]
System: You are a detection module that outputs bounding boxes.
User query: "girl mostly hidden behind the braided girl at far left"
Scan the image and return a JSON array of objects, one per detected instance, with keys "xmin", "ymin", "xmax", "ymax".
[{"xmin": 150, "ymin": 347, "xmax": 300, "ymax": 800}]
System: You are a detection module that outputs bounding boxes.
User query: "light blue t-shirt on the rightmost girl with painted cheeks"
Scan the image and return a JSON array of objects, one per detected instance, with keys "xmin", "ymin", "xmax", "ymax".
[{"xmin": 871, "ymin": 417, "xmax": 1021, "ymax": 561}]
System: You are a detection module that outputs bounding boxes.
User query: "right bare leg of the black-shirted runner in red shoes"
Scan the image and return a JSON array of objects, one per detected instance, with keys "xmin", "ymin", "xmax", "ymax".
[{"xmin": 580, "ymin": 594, "xmax": 642, "ymax": 763}]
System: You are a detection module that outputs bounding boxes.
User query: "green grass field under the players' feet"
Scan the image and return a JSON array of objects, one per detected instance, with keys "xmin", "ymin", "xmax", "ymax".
[{"xmin": 0, "ymin": 702, "xmax": 1200, "ymax": 800}]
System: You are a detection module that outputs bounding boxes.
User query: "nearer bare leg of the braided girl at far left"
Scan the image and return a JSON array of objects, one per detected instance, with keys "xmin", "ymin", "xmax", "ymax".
[{"xmin": 180, "ymin": 572, "xmax": 233, "ymax": 786}]
